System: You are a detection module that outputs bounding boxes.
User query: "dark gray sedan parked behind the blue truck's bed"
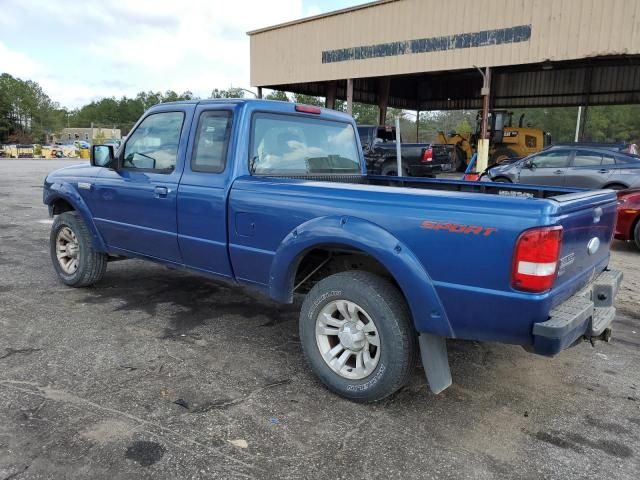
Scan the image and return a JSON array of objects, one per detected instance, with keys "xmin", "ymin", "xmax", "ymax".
[{"xmin": 482, "ymin": 146, "xmax": 640, "ymax": 190}]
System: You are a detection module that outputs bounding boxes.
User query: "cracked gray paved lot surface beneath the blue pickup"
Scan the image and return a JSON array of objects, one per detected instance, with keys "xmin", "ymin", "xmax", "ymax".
[{"xmin": 0, "ymin": 160, "xmax": 640, "ymax": 480}]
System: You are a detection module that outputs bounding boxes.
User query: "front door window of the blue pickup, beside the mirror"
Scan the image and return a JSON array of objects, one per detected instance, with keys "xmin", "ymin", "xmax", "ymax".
[{"xmin": 122, "ymin": 112, "xmax": 184, "ymax": 173}]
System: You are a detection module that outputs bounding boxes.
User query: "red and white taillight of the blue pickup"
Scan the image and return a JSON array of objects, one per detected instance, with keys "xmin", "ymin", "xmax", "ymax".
[{"xmin": 511, "ymin": 226, "xmax": 562, "ymax": 293}]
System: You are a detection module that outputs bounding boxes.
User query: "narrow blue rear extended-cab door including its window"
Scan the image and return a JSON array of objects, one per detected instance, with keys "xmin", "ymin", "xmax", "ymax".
[{"xmin": 178, "ymin": 105, "xmax": 233, "ymax": 277}]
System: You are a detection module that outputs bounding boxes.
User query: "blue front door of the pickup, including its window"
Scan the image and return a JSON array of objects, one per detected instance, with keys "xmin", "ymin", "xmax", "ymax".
[{"xmin": 93, "ymin": 105, "xmax": 193, "ymax": 263}]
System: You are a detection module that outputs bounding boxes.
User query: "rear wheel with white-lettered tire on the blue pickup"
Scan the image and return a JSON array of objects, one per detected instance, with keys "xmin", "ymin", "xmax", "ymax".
[{"xmin": 299, "ymin": 271, "xmax": 418, "ymax": 402}]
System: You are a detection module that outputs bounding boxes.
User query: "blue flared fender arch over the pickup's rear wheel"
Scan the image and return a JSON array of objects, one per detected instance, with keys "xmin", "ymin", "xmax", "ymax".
[{"xmin": 269, "ymin": 216, "xmax": 455, "ymax": 338}]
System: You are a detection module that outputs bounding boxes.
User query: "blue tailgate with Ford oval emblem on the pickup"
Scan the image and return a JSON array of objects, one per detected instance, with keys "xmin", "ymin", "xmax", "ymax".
[{"xmin": 554, "ymin": 190, "xmax": 617, "ymax": 303}]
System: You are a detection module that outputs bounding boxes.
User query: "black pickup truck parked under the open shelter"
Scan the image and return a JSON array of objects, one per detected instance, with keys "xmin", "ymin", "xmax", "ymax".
[{"xmin": 358, "ymin": 125, "xmax": 453, "ymax": 177}]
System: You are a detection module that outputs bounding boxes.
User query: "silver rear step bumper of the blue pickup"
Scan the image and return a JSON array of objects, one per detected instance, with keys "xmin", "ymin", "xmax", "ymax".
[{"xmin": 533, "ymin": 270, "xmax": 622, "ymax": 356}]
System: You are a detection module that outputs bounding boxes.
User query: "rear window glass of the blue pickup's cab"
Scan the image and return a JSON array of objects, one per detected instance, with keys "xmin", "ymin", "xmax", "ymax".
[{"xmin": 250, "ymin": 113, "xmax": 360, "ymax": 175}]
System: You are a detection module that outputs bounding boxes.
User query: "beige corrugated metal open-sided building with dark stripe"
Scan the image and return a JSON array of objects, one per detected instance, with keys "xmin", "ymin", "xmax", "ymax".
[{"xmin": 249, "ymin": 0, "xmax": 640, "ymax": 169}]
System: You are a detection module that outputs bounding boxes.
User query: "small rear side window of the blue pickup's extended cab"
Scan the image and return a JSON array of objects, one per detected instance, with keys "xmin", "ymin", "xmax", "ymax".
[{"xmin": 191, "ymin": 110, "xmax": 231, "ymax": 173}]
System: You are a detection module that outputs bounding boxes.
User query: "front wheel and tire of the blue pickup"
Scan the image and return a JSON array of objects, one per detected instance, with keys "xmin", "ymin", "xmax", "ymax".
[{"xmin": 49, "ymin": 212, "xmax": 108, "ymax": 287}]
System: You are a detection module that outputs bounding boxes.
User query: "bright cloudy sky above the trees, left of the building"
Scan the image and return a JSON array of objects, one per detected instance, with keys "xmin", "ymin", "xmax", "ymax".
[{"xmin": 0, "ymin": 0, "xmax": 365, "ymax": 108}]
